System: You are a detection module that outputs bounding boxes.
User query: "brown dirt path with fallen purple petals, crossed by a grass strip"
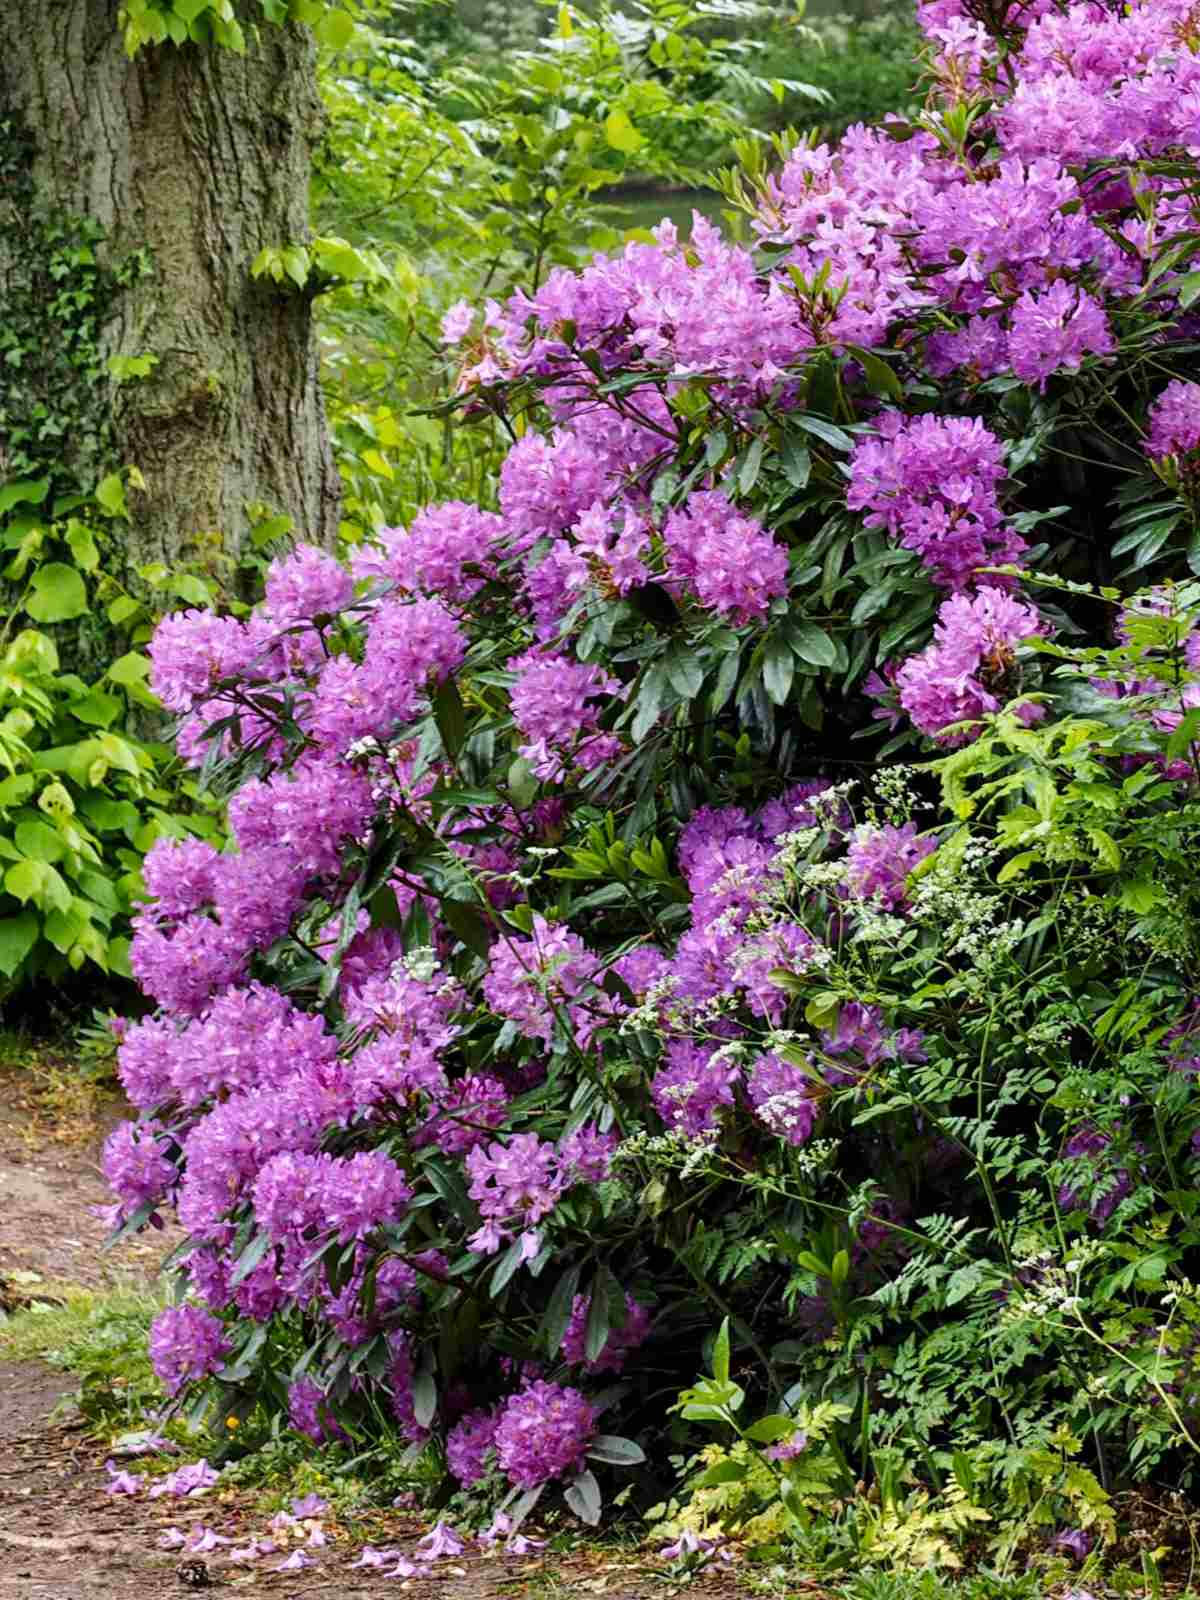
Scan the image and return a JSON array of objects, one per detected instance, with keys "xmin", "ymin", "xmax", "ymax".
[{"xmin": 0, "ymin": 1066, "xmax": 746, "ymax": 1600}]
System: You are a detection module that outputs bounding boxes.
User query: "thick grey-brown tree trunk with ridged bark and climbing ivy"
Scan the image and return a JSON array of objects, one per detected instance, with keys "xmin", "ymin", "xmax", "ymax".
[{"xmin": 0, "ymin": 0, "xmax": 338, "ymax": 576}]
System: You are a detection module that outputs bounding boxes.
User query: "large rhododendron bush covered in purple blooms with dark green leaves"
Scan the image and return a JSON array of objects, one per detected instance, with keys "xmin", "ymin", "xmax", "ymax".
[{"xmin": 106, "ymin": 0, "xmax": 1200, "ymax": 1548}]
